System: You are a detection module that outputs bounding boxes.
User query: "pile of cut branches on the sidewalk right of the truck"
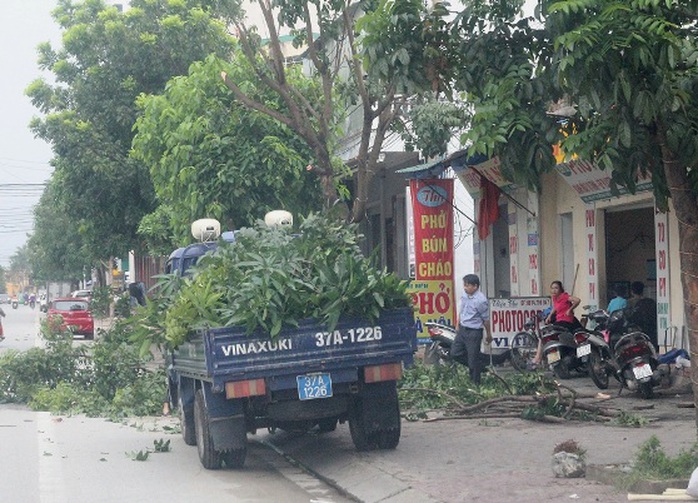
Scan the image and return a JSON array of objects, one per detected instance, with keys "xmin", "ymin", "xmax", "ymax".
[{"xmin": 400, "ymin": 363, "xmax": 642, "ymax": 425}]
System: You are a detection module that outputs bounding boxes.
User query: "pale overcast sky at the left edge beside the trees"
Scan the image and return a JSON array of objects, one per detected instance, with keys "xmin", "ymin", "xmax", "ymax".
[{"xmin": 0, "ymin": 0, "xmax": 60, "ymax": 267}]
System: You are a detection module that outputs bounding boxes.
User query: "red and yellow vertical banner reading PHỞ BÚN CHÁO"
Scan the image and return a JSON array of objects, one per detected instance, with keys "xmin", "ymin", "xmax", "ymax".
[{"xmin": 410, "ymin": 179, "xmax": 456, "ymax": 338}]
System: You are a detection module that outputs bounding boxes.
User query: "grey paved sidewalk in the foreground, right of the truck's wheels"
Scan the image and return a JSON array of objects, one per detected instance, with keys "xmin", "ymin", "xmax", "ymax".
[{"xmin": 262, "ymin": 378, "xmax": 696, "ymax": 503}]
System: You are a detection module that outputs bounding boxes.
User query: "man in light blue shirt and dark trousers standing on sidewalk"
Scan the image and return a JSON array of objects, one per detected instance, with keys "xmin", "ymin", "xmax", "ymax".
[{"xmin": 451, "ymin": 274, "xmax": 492, "ymax": 385}]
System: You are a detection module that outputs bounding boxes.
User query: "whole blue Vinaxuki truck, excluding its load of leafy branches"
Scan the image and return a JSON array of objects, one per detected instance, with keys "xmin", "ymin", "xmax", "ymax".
[{"xmin": 168, "ymin": 219, "xmax": 417, "ymax": 469}]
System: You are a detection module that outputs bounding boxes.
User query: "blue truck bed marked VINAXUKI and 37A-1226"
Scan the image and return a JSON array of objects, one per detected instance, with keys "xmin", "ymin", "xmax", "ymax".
[{"xmin": 173, "ymin": 308, "xmax": 417, "ymax": 391}]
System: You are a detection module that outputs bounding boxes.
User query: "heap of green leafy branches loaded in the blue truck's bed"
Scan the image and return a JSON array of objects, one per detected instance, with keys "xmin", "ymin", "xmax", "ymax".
[{"xmin": 160, "ymin": 214, "xmax": 409, "ymax": 346}]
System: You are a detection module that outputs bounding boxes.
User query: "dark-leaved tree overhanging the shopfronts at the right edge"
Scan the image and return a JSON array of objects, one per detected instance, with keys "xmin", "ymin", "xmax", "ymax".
[{"xmin": 443, "ymin": 0, "xmax": 698, "ymax": 421}]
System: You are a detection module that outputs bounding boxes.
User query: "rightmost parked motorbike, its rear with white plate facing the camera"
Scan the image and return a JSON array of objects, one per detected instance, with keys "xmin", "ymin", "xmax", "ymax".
[{"xmin": 597, "ymin": 309, "xmax": 663, "ymax": 398}]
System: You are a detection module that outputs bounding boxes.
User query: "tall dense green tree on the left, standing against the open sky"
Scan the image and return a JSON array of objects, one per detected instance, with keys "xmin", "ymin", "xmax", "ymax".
[{"xmin": 27, "ymin": 0, "xmax": 235, "ymax": 262}]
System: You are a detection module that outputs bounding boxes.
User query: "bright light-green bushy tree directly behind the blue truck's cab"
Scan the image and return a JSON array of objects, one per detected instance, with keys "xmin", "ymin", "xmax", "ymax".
[{"xmin": 132, "ymin": 51, "xmax": 322, "ymax": 249}]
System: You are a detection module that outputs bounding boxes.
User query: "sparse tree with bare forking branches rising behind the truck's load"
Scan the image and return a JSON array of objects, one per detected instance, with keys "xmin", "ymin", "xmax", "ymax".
[{"xmin": 222, "ymin": 0, "xmax": 452, "ymax": 222}]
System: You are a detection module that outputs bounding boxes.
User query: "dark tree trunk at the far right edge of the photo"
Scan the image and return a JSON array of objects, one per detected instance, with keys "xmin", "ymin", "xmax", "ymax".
[{"xmin": 659, "ymin": 135, "xmax": 698, "ymax": 434}]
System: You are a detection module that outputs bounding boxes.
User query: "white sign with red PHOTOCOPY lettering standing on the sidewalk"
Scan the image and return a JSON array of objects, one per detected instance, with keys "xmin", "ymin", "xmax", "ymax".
[{"xmin": 490, "ymin": 297, "xmax": 550, "ymax": 348}]
